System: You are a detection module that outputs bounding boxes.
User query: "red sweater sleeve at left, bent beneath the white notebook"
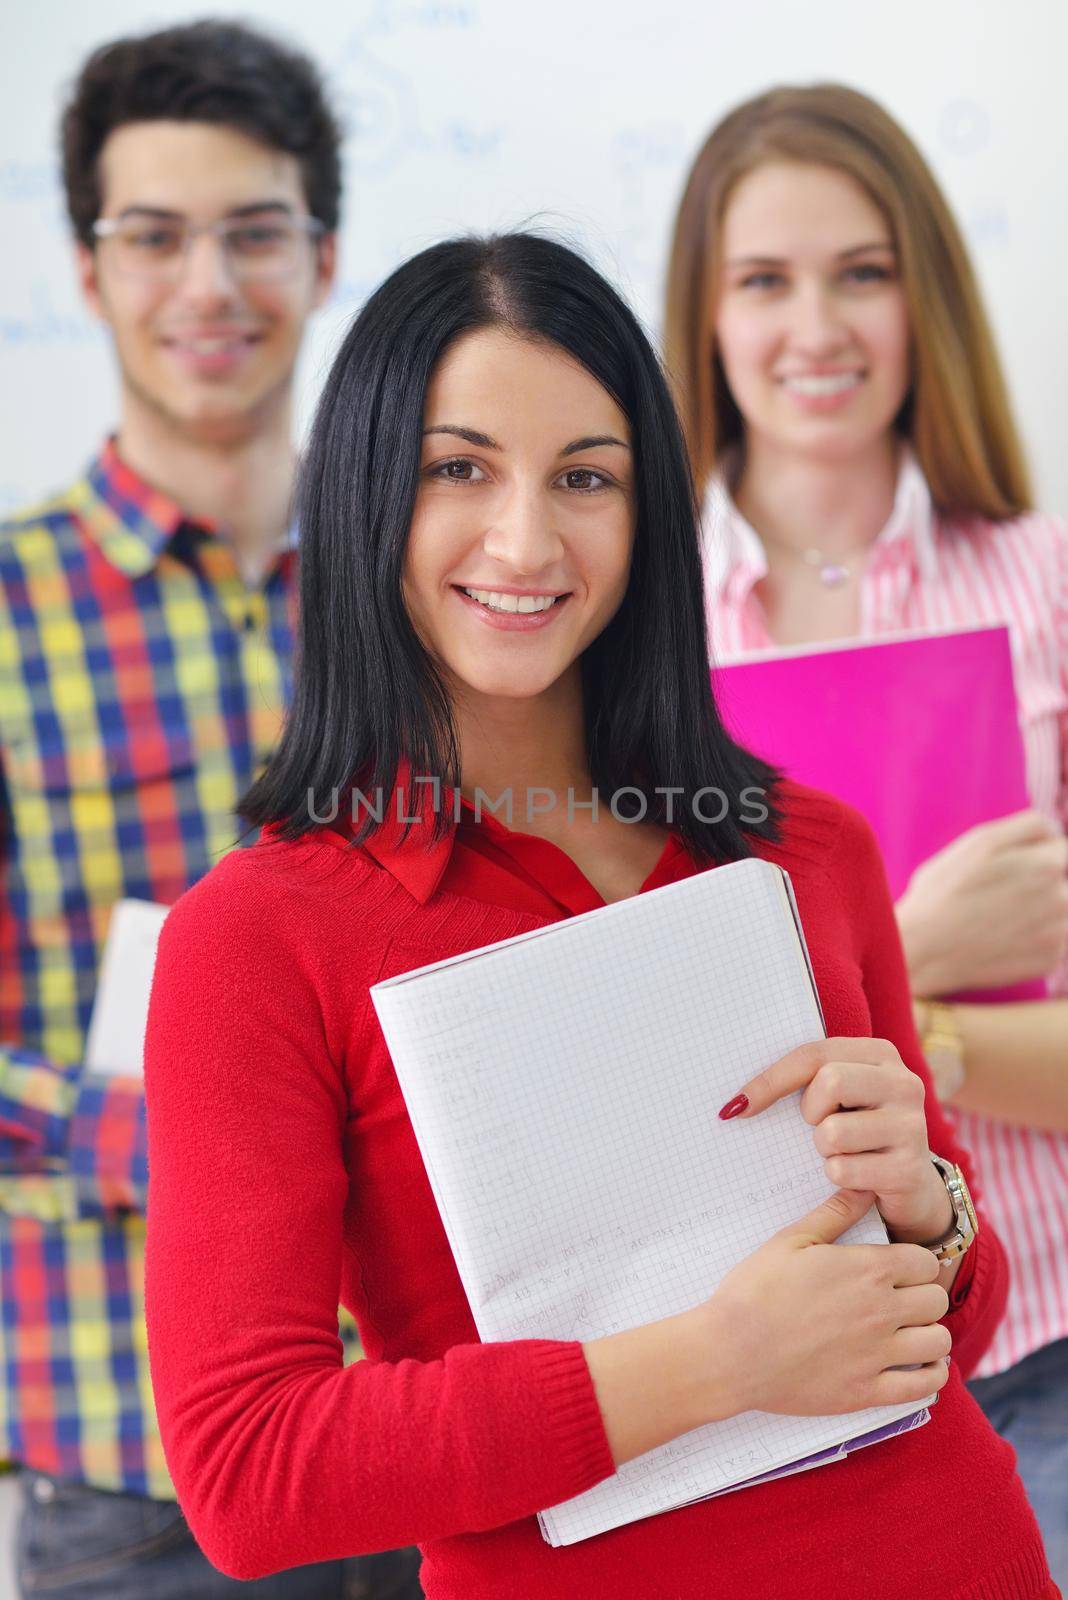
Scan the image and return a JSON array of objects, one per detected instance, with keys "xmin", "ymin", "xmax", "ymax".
[{"xmin": 145, "ymin": 851, "xmax": 612, "ymax": 1579}]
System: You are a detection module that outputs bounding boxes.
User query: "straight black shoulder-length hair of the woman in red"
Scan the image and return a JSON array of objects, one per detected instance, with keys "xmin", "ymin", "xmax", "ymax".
[{"xmin": 240, "ymin": 232, "xmax": 777, "ymax": 861}]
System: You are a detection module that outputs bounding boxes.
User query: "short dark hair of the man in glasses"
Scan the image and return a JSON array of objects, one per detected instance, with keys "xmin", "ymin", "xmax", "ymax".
[{"xmin": 61, "ymin": 19, "xmax": 341, "ymax": 245}]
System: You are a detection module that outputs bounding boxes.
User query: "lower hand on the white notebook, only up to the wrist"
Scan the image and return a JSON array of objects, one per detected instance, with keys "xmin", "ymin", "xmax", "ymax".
[{"xmin": 694, "ymin": 1189, "xmax": 953, "ymax": 1416}]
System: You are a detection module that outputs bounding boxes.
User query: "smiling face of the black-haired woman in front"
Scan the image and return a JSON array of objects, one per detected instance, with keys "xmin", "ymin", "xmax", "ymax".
[{"xmin": 403, "ymin": 328, "xmax": 635, "ymax": 701}]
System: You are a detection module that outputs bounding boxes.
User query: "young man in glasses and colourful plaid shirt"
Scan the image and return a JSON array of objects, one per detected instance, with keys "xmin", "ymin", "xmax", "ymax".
[{"xmin": 0, "ymin": 22, "xmax": 422, "ymax": 1600}]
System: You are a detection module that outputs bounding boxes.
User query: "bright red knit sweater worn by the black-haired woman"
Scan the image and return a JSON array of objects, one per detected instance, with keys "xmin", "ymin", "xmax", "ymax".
[{"xmin": 145, "ymin": 786, "xmax": 1049, "ymax": 1600}]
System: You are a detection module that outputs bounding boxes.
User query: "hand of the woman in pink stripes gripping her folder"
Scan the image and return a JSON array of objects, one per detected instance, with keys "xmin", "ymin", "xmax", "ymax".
[{"xmin": 897, "ymin": 811, "xmax": 1068, "ymax": 995}]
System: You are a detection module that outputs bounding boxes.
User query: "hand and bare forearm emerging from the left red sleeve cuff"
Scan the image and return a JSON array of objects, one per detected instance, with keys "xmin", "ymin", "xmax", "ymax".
[{"xmin": 584, "ymin": 1189, "xmax": 951, "ymax": 1467}]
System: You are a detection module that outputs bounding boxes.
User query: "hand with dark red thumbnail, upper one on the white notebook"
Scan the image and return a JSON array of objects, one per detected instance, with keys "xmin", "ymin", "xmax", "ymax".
[{"xmin": 719, "ymin": 1038, "xmax": 953, "ymax": 1243}]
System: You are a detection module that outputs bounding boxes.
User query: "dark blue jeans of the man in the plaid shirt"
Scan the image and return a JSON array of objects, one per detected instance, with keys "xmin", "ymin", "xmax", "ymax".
[{"xmin": 16, "ymin": 1470, "xmax": 422, "ymax": 1600}]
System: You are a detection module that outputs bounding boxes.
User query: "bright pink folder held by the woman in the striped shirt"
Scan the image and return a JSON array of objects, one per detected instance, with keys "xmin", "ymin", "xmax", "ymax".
[{"xmin": 713, "ymin": 626, "xmax": 1046, "ymax": 1000}]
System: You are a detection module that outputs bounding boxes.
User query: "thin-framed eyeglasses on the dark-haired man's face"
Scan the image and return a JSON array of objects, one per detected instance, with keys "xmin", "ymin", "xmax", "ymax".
[{"xmin": 93, "ymin": 216, "xmax": 326, "ymax": 283}]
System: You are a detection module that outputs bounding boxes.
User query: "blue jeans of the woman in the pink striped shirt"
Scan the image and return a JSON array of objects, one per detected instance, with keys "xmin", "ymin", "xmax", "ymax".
[{"xmin": 970, "ymin": 1339, "xmax": 1068, "ymax": 1589}]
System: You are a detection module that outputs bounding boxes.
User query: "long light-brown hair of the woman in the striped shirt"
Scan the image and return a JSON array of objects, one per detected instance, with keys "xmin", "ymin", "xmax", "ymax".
[{"xmin": 665, "ymin": 83, "xmax": 1031, "ymax": 518}]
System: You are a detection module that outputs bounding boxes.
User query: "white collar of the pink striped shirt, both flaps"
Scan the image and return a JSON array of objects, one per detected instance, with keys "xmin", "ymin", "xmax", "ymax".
[{"xmin": 702, "ymin": 445, "xmax": 937, "ymax": 598}]
